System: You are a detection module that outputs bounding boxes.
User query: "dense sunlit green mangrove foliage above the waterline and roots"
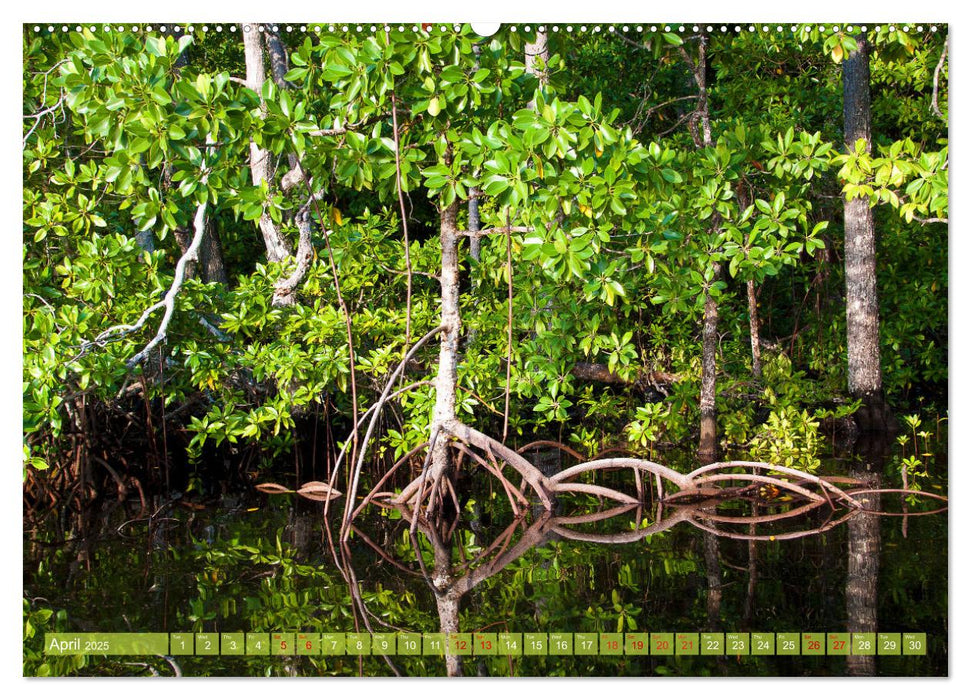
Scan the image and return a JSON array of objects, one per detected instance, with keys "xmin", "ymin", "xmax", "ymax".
[{"xmin": 23, "ymin": 25, "xmax": 949, "ymax": 486}]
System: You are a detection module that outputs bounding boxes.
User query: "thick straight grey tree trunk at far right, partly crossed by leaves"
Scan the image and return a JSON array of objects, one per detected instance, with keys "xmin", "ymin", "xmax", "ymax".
[{"xmin": 843, "ymin": 36, "xmax": 889, "ymax": 431}]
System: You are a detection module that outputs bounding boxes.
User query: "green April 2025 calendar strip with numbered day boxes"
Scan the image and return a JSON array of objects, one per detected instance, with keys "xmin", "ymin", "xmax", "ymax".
[{"xmin": 44, "ymin": 632, "xmax": 927, "ymax": 658}]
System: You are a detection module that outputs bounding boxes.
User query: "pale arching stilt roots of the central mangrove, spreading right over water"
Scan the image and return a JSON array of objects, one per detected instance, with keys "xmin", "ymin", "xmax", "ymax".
[{"xmin": 355, "ymin": 421, "xmax": 947, "ymax": 540}]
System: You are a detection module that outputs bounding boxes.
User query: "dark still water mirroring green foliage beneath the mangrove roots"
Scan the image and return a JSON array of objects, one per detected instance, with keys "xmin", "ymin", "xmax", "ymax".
[{"xmin": 24, "ymin": 448, "xmax": 948, "ymax": 676}]
